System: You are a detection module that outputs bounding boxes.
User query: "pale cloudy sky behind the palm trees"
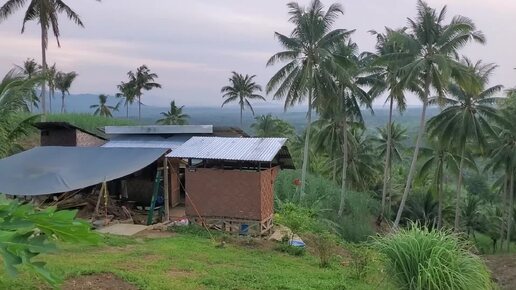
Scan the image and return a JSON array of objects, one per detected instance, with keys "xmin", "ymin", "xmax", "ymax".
[{"xmin": 0, "ymin": 0, "xmax": 516, "ymax": 106}]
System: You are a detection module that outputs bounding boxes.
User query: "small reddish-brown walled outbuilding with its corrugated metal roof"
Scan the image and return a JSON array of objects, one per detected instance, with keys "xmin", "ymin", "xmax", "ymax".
[{"xmin": 167, "ymin": 137, "xmax": 294, "ymax": 235}]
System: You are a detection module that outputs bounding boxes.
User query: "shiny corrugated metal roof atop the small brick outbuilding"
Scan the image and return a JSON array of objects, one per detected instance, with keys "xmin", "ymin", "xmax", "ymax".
[{"xmin": 167, "ymin": 137, "xmax": 287, "ymax": 162}]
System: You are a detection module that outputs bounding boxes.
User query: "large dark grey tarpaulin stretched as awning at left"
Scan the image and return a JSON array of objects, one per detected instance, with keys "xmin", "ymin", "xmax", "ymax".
[{"xmin": 0, "ymin": 146, "xmax": 168, "ymax": 195}]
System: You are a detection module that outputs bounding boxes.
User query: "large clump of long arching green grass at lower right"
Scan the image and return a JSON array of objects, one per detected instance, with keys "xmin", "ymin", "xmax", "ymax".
[{"xmin": 375, "ymin": 224, "xmax": 494, "ymax": 290}]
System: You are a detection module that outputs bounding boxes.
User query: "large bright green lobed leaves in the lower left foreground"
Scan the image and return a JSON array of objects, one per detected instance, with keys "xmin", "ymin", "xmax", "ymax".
[{"xmin": 0, "ymin": 197, "xmax": 99, "ymax": 285}]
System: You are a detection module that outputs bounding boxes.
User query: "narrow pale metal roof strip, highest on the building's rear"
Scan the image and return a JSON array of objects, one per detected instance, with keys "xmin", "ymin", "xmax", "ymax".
[{"xmin": 104, "ymin": 125, "xmax": 213, "ymax": 135}]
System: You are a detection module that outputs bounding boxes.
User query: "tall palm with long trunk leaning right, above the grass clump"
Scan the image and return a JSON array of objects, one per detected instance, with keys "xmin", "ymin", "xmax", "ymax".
[{"xmin": 392, "ymin": 0, "xmax": 485, "ymax": 227}]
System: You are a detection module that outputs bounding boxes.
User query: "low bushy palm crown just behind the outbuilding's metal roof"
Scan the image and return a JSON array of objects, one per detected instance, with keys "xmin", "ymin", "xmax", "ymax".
[{"xmin": 251, "ymin": 113, "xmax": 296, "ymax": 138}]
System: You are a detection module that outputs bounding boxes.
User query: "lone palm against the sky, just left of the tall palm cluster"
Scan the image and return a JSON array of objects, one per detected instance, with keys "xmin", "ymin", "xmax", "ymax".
[{"xmin": 220, "ymin": 72, "xmax": 265, "ymax": 127}]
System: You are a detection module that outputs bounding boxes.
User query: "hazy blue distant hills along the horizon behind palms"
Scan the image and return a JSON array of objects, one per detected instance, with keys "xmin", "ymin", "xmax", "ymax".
[{"xmin": 48, "ymin": 94, "xmax": 438, "ymax": 132}]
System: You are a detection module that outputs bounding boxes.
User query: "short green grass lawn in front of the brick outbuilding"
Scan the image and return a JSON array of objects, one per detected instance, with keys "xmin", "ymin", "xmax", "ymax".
[{"xmin": 0, "ymin": 233, "xmax": 393, "ymax": 290}]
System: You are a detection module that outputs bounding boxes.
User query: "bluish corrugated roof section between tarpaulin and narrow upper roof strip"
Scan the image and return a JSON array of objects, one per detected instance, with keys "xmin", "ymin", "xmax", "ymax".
[{"xmin": 102, "ymin": 134, "xmax": 192, "ymax": 150}]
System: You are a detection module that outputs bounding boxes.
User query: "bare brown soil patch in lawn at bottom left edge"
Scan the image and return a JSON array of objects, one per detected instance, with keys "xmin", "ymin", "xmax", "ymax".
[{"xmin": 62, "ymin": 273, "xmax": 138, "ymax": 290}]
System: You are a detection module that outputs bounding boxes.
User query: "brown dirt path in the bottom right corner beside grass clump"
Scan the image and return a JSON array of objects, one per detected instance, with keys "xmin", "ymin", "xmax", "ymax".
[{"xmin": 484, "ymin": 255, "xmax": 516, "ymax": 290}]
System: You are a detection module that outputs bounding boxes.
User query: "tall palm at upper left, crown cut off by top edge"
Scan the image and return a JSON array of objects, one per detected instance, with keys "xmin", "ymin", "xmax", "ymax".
[{"xmin": 0, "ymin": 0, "xmax": 93, "ymax": 115}]
